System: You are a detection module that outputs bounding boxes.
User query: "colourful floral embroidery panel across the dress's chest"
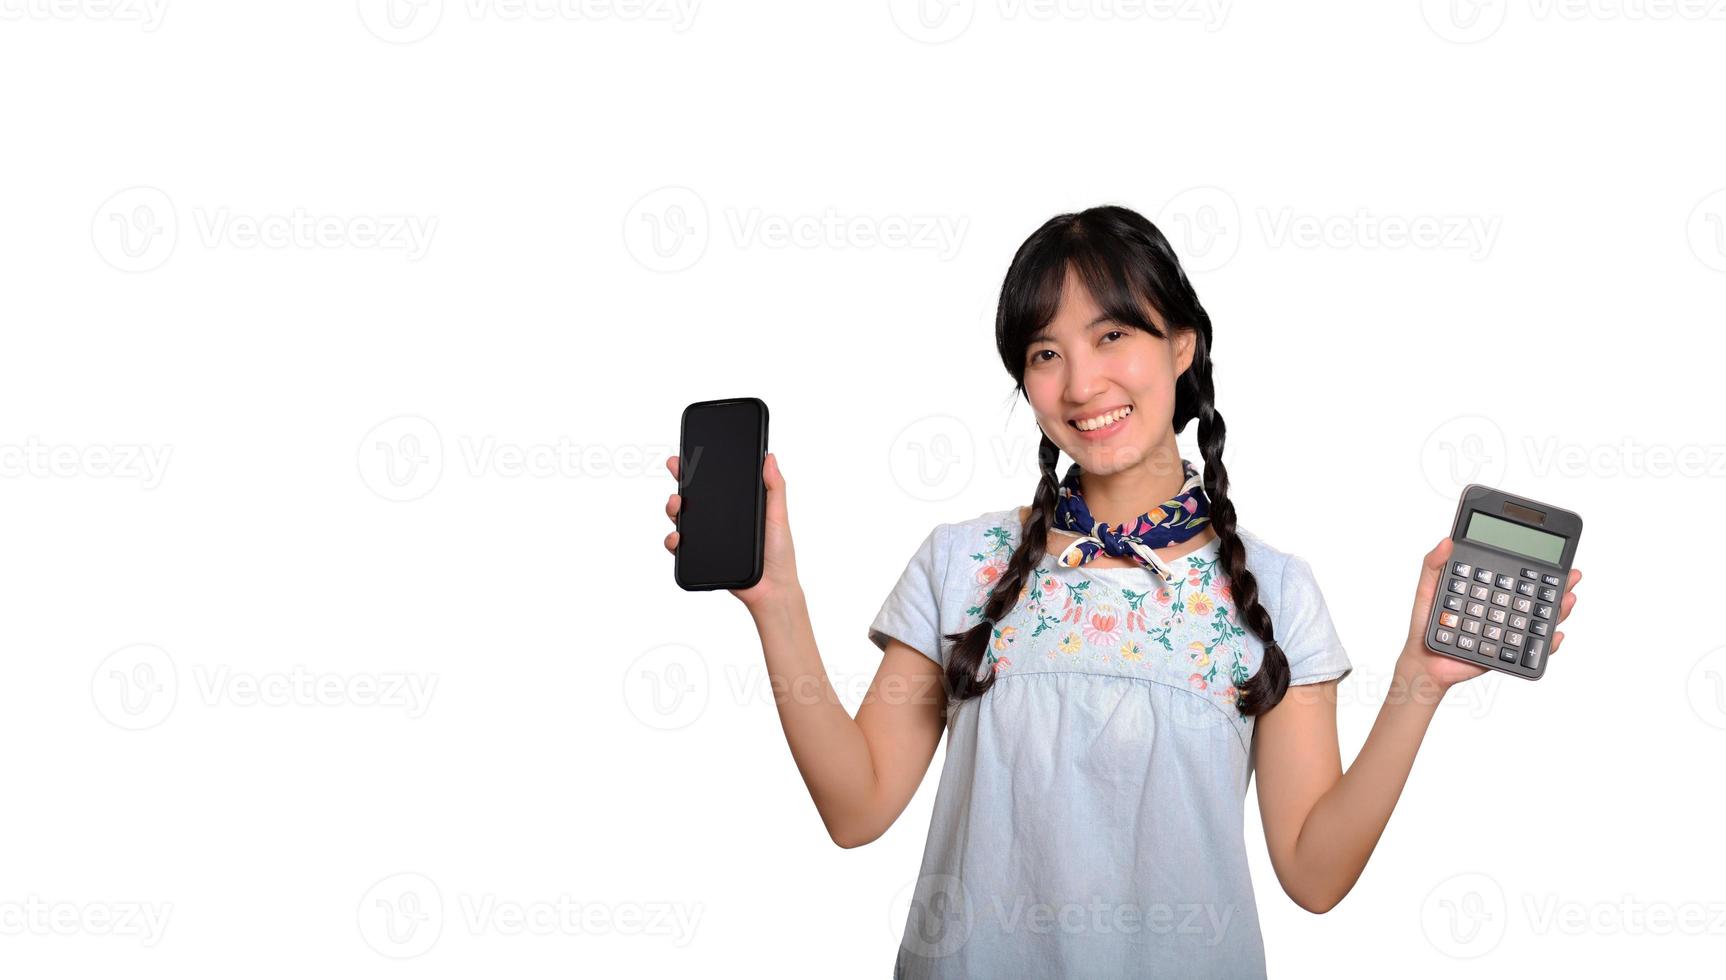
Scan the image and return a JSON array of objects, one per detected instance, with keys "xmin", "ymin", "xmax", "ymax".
[{"xmin": 967, "ymin": 525, "xmax": 1250, "ymax": 706}]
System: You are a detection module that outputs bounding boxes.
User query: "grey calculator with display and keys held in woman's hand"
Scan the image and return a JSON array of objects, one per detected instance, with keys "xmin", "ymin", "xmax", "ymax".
[{"xmin": 1426, "ymin": 483, "xmax": 1583, "ymax": 680}]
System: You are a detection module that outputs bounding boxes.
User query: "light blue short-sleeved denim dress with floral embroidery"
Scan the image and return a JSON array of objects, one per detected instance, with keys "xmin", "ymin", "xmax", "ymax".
[{"xmin": 868, "ymin": 507, "xmax": 1351, "ymax": 980}]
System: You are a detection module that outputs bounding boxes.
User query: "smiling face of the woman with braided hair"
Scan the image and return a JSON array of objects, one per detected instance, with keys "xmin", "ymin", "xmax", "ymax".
[{"xmin": 1025, "ymin": 269, "xmax": 1193, "ymax": 476}]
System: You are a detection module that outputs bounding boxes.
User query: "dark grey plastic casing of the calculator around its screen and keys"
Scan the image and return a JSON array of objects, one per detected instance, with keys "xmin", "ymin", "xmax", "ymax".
[{"xmin": 1424, "ymin": 483, "xmax": 1583, "ymax": 680}]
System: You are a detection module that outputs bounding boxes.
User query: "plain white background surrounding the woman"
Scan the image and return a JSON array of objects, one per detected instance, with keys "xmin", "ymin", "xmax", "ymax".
[{"xmin": 0, "ymin": 0, "xmax": 1726, "ymax": 977}]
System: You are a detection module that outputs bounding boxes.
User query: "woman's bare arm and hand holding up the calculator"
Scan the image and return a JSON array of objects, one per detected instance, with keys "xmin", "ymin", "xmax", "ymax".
[{"xmin": 1255, "ymin": 538, "xmax": 1583, "ymax": 913}]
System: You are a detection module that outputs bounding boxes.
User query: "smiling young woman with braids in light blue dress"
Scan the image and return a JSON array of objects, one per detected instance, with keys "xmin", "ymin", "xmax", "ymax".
[{"xmin": 666, "ymin": 207, "xmax": 1581, "ymax": 978}]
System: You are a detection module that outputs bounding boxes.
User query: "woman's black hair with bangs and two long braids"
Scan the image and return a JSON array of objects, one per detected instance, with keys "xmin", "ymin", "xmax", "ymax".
[{"xmin": 944, "ymin": 205, "xmax": 1289, "ymax": 716}]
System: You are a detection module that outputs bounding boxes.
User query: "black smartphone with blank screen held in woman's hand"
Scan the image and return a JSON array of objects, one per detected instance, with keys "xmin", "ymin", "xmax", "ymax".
[{"xmin": 675, "ymin": 399, "xmax": 766, "ymax": 592}]
